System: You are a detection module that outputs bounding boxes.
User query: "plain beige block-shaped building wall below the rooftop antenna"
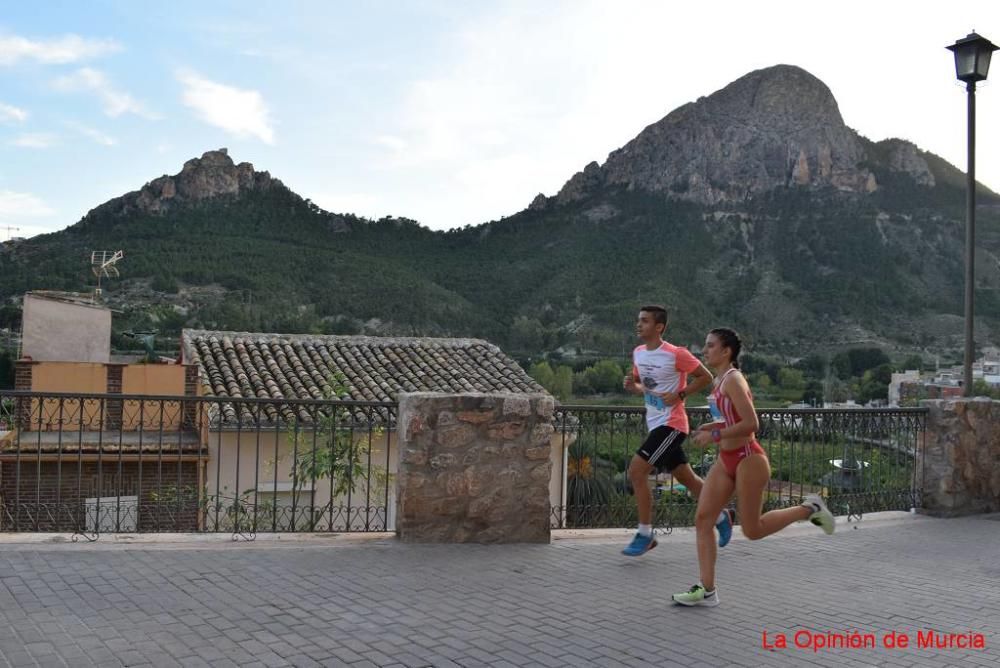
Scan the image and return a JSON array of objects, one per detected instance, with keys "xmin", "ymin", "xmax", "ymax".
[{"xmin": 21, "ymin": 293, "xmax": 111, "ymax": 363}]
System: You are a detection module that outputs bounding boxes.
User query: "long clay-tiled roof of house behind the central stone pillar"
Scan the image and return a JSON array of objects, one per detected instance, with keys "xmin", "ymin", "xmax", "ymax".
[{"xmin": 182, "ymin": 329, "xmax": 545, "ymax": 426}]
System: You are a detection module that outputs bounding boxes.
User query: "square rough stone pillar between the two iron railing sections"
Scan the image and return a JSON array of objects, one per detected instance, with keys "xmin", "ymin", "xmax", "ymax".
[{"xmin": 396, "ymin": 392, "xmax": 554, "ymax": 543}]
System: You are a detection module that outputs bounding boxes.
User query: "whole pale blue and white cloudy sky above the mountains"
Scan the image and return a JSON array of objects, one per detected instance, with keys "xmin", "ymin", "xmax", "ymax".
[{"xmin": 0, "ymin": 0, "xmax": 1000, "ymax": 240}]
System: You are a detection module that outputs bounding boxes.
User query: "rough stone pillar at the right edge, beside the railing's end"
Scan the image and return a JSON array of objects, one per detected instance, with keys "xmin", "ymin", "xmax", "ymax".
[{"xmin": 917, "ymin": 398, "xmax": 1000, "ymax": 515}]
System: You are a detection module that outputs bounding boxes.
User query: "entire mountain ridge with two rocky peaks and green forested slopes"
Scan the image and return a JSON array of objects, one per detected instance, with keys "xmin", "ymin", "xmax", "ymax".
[{"xmin": 0, "ymin": 65, "xmax": 1000, "ymax": 362}]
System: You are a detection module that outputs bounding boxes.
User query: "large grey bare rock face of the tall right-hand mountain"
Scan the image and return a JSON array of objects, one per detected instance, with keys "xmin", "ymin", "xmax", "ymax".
[{"xmin": 558, "ymin": 65, "xmax": 888, "ymax": 204}]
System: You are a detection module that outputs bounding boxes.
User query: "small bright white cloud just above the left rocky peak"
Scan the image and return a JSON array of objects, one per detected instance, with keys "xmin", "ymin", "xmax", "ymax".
[{"xmin": 177, "ymin": 71, "xmax": 274, "ymax": 144}]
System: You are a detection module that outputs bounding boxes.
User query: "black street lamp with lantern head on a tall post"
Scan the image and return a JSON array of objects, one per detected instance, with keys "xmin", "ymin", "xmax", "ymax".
[{"xmin": 947, "ymin": 32, "xmax": 1000, "ymax": 397}]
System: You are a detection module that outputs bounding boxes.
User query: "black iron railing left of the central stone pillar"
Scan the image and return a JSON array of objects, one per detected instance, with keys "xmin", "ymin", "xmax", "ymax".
[{"xmin": 0, "ymin": 391, "xmax": 396, "ymax": 538}]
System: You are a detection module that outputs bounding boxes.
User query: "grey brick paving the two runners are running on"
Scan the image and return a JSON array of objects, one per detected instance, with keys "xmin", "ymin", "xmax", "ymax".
[{"xmin": 0, "ymin": 515, "xmax": 1000, "ymax": 668}]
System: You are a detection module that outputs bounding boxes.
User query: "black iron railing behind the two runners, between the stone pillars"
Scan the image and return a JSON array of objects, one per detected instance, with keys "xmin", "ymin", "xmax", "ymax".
[{"xmin": 551, "ymin": 405, "xmax": 927, "ymax": 530}]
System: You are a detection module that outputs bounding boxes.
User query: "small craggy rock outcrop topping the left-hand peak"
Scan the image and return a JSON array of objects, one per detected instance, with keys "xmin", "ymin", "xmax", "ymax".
[{"xmin": 91, "ymin": 148, "xmax": 282, "ymax": 215}]
